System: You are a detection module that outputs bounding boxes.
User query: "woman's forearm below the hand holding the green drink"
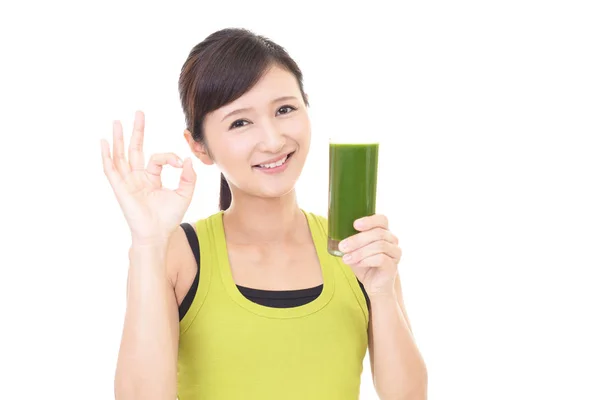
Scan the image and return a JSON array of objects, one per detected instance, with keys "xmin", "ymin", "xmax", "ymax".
[{"xmin": 370, "ymin": 286, "xmax": 427, "ymax": 400}]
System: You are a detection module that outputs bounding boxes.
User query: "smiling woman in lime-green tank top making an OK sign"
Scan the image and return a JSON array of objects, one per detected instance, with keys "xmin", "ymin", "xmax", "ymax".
[{"xmin": 101, "ymin": 29, "xmax": 427, "ymax": 400}]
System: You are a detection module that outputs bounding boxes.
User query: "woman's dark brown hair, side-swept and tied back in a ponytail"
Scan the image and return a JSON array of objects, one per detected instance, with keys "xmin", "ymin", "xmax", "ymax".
[{"xmin": 179, "ymin": 28, "xmax": 308, "ymax": 211}]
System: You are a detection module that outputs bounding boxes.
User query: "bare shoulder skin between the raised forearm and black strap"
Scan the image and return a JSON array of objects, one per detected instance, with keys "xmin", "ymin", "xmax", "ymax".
[{"xmin": 166, "ymin": 223, "xmax": 198, "ymax": 305}]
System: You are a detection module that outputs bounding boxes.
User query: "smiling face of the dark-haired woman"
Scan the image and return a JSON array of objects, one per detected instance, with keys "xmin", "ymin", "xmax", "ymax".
[{"xmin": 201, "ymin": 66, "xmax": 311, "ymax": 197}]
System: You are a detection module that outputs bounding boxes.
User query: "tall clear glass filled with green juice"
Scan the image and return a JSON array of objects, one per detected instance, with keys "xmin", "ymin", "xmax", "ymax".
[{"xmin": 327, "ymin": 139, "xmax": 379, "ymax": 257}]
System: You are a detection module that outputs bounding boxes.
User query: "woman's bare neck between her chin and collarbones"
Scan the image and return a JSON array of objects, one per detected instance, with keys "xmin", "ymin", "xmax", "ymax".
[{"xmin": 223, "ymin": 189, "xmax": 305, "ymax": 244}]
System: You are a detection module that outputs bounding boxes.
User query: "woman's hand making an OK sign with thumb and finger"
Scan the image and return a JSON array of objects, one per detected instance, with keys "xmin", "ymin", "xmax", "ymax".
[{"xmin": 100, "ymin": 111, "xmax": 196, "ymax": 245}]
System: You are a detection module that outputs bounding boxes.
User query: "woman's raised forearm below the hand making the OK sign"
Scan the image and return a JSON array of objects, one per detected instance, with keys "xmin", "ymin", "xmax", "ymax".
[{"xmin": 115, "ymin": 244, "xmax": 179, "ymax": 400}]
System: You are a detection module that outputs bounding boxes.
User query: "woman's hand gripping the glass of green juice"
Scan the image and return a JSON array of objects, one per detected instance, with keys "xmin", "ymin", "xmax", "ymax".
[{"xmin": 340, "ymin": 214, "xmax": 402, "ymax": 296}]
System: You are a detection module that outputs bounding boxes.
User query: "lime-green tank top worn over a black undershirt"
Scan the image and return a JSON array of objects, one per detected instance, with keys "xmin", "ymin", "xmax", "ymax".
[{"xmin": 177, "ymin": 212, "xmax": 369, "ymax": 400}]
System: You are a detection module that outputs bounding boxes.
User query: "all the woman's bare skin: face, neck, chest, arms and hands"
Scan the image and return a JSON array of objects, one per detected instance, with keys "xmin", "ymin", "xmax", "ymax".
[{"xmin": 102, "ymin": 66, "xmax": 427, "ymax": 400}]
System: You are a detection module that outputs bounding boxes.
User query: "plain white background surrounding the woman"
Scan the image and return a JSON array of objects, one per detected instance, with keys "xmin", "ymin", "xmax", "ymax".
[{"xmin": 0, "ymin": 0, "xmax": 600, "ymax": 400}]
